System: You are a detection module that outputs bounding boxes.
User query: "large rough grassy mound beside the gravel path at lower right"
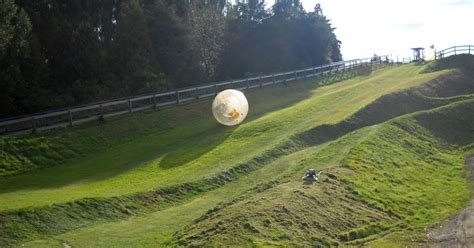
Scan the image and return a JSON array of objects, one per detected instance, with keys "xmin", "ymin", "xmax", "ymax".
[{"xmin": 173, "ymin": 100, "xmax": 474, "ymax": 246}]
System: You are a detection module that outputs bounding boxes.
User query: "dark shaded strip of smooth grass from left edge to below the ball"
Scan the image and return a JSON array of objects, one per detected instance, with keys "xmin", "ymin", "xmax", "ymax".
[{"xmin": 0, "ymin": 124, "xmax": 234, "ymax": 193}]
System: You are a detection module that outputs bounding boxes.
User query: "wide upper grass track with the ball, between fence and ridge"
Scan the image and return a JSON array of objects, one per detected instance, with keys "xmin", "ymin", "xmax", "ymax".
[{"xmin": 0, "ymin": 65, "xmax": 450, "ymax": 210}]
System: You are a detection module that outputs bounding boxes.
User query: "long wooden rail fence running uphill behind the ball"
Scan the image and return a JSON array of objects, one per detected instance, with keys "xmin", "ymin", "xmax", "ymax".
[{"xmin": 0, "ymin": 55, "xmax": 393, "ymax": 135}]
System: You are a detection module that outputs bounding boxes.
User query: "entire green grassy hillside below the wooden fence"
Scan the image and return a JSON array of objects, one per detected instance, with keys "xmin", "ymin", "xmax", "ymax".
[{"xmin": 0, "ymin": 55, "xmax": 474, "ymax": 247}]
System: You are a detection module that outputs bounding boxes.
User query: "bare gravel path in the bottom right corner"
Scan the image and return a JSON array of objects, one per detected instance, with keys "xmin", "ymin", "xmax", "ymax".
[{"xmin": 427, "ymin": 155, "xmax": 474, "ymax": 247}]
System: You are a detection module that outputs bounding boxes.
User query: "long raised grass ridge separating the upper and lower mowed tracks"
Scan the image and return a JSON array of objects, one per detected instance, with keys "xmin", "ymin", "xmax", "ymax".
[{"xmin": 0, "ymin": 70, "xmax": 470, "ymax": 246}]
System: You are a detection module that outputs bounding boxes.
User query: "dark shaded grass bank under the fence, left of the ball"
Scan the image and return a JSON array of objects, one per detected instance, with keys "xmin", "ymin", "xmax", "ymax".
[{"xmin": 0, "ymin": 102, "xmax": 211, "ymax": 176}]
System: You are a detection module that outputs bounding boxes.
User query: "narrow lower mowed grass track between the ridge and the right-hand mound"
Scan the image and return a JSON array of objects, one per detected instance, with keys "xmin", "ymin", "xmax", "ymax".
[{"xmin": 24, "ymin": 123, "xmax": 376, "ymax": 247}]
